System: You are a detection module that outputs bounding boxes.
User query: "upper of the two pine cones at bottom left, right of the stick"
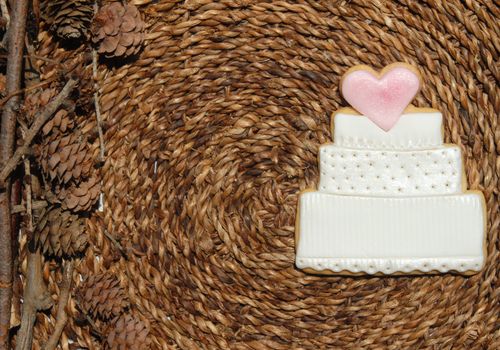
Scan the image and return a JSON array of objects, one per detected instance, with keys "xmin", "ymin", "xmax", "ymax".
[{"xmin": 77, "ymin": 272, "xmax": 129, "ymax": 320}]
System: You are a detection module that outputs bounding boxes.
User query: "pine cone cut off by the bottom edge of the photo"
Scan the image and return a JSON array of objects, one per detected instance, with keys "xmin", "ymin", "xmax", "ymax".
[{"xmin": 105, "ymin": 313, "xmax": 151, "ymax": 350}]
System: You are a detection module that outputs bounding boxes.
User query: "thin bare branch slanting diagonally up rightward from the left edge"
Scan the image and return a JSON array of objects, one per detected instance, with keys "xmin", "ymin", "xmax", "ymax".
[{"xmin": 0, "ymin": 80, "xmax": 76, "ymax": 186}]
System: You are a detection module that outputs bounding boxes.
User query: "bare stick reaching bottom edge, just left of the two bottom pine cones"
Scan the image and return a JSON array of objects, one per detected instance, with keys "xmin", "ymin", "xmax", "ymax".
[{"xmin": 44, "ymin": 260, "xmax": 74, "ymax": 350}]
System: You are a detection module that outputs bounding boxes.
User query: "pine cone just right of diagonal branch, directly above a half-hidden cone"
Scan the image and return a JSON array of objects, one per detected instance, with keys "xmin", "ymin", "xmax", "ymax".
[{"xmin": 36, "ymin": 132, "xmax": 94, "ymax": 184}]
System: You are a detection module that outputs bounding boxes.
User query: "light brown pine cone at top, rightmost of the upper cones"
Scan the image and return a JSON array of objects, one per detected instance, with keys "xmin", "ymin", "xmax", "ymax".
[{"xmin": 91, "ymin": 2, "xmax": 144, "ymax": 58}]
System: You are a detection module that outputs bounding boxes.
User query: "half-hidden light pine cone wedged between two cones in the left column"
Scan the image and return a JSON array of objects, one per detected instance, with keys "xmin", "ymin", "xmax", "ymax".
[{"xmin": 50, "ymin": 176, "xmax": 101, "ymax": 212}]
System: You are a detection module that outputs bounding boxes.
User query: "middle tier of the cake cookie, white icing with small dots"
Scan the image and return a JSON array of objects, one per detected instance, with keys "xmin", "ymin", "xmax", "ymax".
[{"xmin": 318, "ymin": 144, "xmax": 465, "ymax": 196}]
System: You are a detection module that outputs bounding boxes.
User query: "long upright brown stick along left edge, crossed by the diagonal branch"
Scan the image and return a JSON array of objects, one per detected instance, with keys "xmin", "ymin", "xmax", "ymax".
[{"xmin": 0, "ymin": 0, "xmax": 28, "ymax": 349}]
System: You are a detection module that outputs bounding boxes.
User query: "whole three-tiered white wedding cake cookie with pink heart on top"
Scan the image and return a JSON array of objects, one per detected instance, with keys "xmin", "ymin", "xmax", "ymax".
[{"xmin": 296, "ymin": 63, "xmax": 485, "ymax": 274}]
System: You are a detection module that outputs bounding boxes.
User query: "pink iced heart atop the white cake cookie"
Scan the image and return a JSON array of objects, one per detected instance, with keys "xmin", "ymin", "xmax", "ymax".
[{"xmin": 341, "ymin": 65, "xmax": 420, "ymax": 131}]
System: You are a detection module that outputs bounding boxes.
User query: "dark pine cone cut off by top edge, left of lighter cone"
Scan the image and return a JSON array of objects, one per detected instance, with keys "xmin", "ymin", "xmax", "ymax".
[{"xmin": 43, "ymin": 0, "xmax": 94, "ymax": 40}]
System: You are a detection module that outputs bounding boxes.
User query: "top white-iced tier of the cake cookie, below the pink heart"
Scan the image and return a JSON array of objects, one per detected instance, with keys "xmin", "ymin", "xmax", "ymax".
[{"xmin": 333, "ymin": 111, "xmax": 443, "ymax": 150}]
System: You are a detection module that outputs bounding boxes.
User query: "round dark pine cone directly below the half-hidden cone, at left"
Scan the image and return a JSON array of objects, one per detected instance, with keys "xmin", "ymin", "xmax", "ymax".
[{"xmin": 35, "ymin": 208, "xmax": 87, "ymax": 256}]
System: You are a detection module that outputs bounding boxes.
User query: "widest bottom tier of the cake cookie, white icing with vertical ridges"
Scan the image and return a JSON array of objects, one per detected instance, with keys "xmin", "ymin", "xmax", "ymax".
[{"xmin": 295, "ymin": 192, "xmax": 485, "ymax": 274}]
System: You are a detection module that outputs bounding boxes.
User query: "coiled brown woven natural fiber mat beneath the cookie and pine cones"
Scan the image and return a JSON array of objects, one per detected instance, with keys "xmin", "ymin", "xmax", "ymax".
[{"xmin": 30, "ymin": 0, "xmax": 500, "ymax": 349}]
